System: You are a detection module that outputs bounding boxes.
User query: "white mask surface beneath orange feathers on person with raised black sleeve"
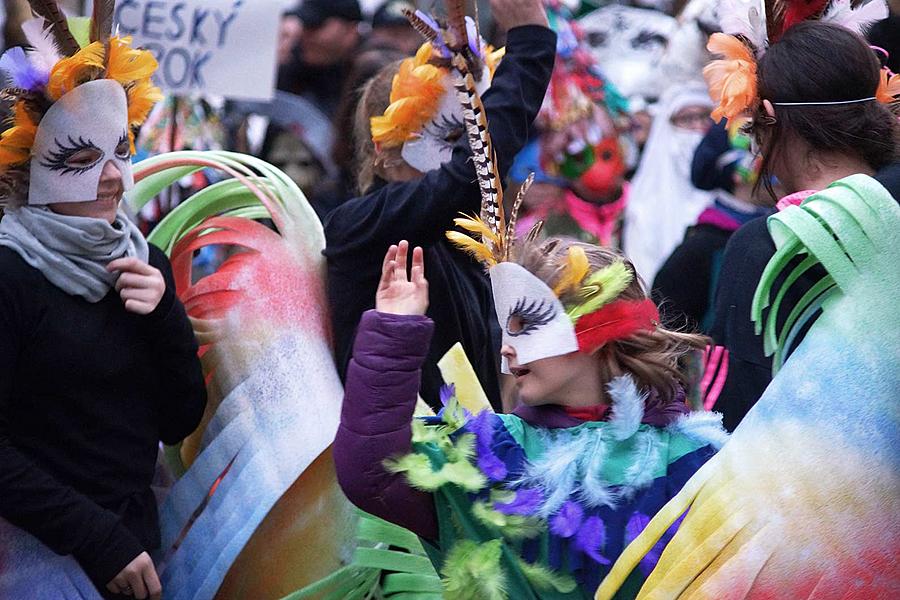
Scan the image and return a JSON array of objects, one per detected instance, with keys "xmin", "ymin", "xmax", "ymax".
[{"xmin": 400, "ymin": 68, "xmax": 491, "ymax": 173}]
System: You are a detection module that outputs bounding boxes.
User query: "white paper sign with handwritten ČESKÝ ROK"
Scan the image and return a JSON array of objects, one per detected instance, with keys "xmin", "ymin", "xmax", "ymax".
[{"xmin": 115, "ymin": 0, "xmax": 281, "ymax": 100}]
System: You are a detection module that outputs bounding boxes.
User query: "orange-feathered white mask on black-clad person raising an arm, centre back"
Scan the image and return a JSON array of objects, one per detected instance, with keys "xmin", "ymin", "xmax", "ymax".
[{"xmin": 370, "ymin": 0, "xmax": 503, "ymax": 172}]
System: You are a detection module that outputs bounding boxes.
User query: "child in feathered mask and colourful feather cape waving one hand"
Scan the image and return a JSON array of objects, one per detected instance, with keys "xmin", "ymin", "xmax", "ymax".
[{"xmin": 334, "ymin": 229, "xmax": 725, "ymax": 599}]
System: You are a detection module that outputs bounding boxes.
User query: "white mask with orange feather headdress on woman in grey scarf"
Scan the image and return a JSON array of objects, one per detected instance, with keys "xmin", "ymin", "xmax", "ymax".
[{"xmin": 0, "ymin": 0, "xmax": 162, "ymax": 203}]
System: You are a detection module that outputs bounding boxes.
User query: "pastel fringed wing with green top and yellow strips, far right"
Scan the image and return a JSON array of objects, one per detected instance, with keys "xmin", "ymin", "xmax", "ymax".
[{"xmin": 596, "ymin": 175, "xmax": 900, "ymax": 599}]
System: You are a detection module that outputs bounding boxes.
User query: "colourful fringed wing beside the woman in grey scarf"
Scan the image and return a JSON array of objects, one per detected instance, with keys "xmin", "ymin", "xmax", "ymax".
[{"xmin": 129, "ymin": 152, "xmax": 354, "ymax": 600}]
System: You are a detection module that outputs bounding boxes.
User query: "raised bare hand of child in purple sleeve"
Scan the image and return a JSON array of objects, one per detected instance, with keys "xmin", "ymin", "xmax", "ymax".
[{"xmin": 375, "ymin": 240, "xmax": 428, "ymax": 315}]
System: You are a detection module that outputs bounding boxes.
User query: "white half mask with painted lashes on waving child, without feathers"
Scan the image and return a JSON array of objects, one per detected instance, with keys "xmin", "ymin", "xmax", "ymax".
[{"xmin": 489, "ymin": 262, "xmax": 578, "ymax": 373}]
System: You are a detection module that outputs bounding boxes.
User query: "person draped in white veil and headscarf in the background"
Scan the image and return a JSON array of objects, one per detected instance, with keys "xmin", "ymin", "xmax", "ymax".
[{"xmin": 622, "ymin": 82, "xmax": 714, "ymax": 282}]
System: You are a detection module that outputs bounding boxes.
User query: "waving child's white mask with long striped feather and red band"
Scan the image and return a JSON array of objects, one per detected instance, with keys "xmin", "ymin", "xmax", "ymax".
[{"xmin": 447, "ymin": 41, "xmax": 659, "ymax": 372}]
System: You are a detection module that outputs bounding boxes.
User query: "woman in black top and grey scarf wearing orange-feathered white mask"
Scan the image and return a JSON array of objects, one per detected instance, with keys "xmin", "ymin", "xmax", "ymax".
[{"xmin": 0, "ymin": 2, "xmax": 206, "ymax": 598}]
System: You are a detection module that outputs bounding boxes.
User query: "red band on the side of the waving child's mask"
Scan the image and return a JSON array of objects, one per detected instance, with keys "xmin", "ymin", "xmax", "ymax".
[{"xmin": 575, "ymin": 299, "xmax": 659, "ymax": 354}]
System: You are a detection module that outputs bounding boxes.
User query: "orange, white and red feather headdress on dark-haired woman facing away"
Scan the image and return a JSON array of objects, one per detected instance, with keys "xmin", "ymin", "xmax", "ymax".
[{"xmin": 703, "ymin": 0, "xmax": 900, "ymax": 122}]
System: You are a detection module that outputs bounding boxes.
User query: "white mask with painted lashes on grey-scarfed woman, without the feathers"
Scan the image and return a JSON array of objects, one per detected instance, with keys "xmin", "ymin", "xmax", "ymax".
[{"xmin": 28, "ymin": 79, "xmax": 134, "ymax": 206}]
